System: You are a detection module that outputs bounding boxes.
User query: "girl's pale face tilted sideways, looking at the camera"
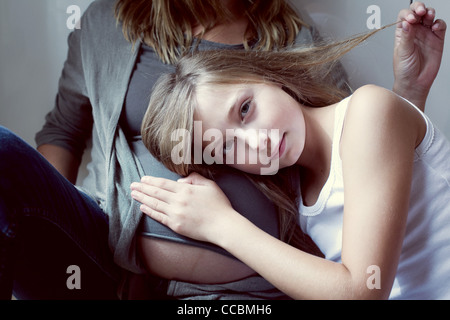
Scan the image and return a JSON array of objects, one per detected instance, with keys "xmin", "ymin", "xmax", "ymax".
[{"xmin": 194, "ymin": 84, "xmax": 306, "ymax": 174}]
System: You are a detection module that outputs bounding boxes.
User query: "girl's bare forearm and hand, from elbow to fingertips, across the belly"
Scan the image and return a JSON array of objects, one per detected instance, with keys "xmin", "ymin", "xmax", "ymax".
[{"xmin": 131, "ymin": 174, "xmax": 354, "ymax": 299}]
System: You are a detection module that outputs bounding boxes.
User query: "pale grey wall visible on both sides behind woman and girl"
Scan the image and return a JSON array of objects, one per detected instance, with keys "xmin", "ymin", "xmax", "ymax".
[{"xmin": 0, "ymin": 0, "xmax": 450, "ymax": 182}]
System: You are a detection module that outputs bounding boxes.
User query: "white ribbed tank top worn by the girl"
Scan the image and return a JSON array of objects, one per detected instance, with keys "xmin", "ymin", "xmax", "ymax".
[{"xmin": 300, "ymin": 97, "xmax": 450, "ymax": 299}]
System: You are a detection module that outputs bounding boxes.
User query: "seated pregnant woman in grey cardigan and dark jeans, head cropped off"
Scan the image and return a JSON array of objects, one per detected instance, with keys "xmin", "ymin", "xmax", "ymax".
[{"xmin": 0, "ymin": 0, "xmax": 440, "ymax": 299}]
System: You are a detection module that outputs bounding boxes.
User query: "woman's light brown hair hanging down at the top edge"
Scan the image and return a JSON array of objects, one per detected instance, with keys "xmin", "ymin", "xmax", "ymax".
[{"xmin": 115, "ymin": 0, "xmax": 306, "ymax": 64}]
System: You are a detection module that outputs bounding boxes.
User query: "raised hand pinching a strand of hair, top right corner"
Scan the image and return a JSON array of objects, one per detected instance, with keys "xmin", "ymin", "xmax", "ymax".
[{"xmin": 393, "ymin": 2, "xmax": 447, "ymax": 111}]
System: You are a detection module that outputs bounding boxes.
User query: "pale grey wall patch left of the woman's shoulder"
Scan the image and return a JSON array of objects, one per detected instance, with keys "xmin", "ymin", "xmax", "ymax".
[{"xmin": 0, "ymin": 0, "xmax": 92, "ymax": 146}]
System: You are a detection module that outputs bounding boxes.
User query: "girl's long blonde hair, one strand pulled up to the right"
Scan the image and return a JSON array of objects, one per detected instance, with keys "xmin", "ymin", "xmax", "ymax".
[{"xmin": 141, "ymin": 26, "xmax": 394, "ymax": 256}]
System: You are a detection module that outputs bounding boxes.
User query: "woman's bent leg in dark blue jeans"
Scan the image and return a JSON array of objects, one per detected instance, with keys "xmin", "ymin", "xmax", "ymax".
[{"xmin": 0, "ymin": 127, "xmax": 121, "ymax": 299}]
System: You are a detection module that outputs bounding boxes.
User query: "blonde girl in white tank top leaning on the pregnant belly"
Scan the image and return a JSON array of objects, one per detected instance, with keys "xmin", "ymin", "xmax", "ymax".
[{"xmin": 131, "ymin": 10, "xmax": 450, "ymax": 299}]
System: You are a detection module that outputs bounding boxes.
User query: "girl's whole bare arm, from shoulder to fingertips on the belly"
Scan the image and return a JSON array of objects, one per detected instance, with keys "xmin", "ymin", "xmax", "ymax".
[{"xmin": 132, "ymin": 86, "xmax": 425, "ymax": 299}]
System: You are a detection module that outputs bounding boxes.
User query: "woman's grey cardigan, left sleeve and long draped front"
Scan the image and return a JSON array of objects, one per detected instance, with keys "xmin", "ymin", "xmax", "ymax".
[{"xmin": 36, "ymin": 0, "xmax": 350, "ymax": 273}]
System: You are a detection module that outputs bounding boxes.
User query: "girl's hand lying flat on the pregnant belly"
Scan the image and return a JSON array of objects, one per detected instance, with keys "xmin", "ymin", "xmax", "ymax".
[{"xmin": 131, "ymin": 173, "xmax": 236, "ymax": 243}]
